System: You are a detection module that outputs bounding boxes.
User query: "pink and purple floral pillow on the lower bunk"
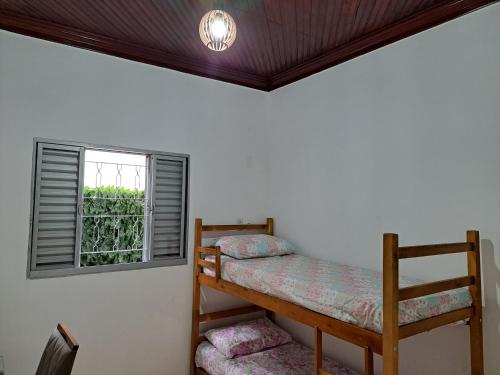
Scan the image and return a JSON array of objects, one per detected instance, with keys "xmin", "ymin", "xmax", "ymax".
[{"xmin": 205, "ymin": 318, "xmax": 292, "ymax": 358}]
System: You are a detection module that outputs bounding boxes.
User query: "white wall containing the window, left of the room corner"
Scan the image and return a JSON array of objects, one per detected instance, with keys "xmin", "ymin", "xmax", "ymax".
[{"xmin": 0, "ymin": 31, "xmax": 268, "ymax": 375}]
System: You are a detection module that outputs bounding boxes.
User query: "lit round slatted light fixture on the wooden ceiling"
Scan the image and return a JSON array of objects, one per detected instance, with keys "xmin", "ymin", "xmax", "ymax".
[{"xmin": 200, "ymin": 10, "xmax": 236, "ymax": 52}]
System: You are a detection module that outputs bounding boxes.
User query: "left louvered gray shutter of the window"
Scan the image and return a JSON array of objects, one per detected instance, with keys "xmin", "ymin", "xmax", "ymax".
[{"xmin": 30, "ymin": 143, "xmax": 84, "ymax": 274}]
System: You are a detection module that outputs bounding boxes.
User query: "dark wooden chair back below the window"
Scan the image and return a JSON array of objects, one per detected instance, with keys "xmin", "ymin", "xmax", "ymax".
[{"xmin": 36, "ymin": 323, "xmax": 79, "ymax": 375}]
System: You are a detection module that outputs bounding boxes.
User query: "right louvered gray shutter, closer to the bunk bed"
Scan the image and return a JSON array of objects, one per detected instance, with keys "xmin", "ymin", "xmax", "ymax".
[{"xmin": 149, "ymin": 155, "xmax": 188, "ymax": 261}]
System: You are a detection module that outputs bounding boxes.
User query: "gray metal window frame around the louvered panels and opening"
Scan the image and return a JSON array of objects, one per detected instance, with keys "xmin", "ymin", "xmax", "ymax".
[{"xmin": 26, "ymin": 137, "xmax": 190, "ymax": 279}]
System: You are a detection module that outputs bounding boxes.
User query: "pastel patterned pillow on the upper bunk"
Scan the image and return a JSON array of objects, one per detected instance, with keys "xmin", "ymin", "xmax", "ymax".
[{"xmin": 215, "ymin": 234, "xmax": 295, "ymax": 259}]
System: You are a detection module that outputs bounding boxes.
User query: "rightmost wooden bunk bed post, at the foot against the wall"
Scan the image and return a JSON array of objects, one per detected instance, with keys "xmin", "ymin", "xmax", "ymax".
[{"xmin": 467, "ymin": 230, "xmax": 484, "ymax": 375}]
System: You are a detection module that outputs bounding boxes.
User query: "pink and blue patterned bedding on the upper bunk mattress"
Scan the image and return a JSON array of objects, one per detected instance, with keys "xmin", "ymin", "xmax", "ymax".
[{"xmin": 204, "ymin": 254, "xmax": 472, "ymax": 333}]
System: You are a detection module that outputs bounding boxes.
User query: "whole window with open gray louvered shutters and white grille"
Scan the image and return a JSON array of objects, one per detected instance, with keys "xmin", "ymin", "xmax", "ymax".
[{"xmin": 28, "ymin": 139, "xmax": 189, "ymax": 278}]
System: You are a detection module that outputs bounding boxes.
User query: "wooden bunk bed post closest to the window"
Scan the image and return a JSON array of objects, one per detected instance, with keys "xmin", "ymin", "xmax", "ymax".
[{"xmin": 189, "ymin": 219, "xmax": 203, "ymax": 375}]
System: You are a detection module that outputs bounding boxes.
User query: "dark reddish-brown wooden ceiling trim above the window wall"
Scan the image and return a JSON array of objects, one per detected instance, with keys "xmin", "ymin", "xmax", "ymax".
[{"xmin": 0, "ymin": 10, "xmax": 269, "ymax": 91}]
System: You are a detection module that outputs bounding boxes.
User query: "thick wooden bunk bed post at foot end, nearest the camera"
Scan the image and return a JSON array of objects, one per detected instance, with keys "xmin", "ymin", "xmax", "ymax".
[{"xmin": 382, "ymin": 233, "xmax": 399, "ymax": 375}]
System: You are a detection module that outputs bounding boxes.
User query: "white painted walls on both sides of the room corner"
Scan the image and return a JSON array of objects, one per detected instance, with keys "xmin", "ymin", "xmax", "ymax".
[{"xmin": 0, "ymin": 5, "xmax": 500, "ymax": 375}]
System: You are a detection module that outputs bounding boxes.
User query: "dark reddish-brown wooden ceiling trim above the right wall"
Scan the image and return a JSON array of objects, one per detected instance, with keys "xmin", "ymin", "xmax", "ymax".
[{"xmin": 270, "ymin": 0, "xmax": 499, "ymax": 90}]
